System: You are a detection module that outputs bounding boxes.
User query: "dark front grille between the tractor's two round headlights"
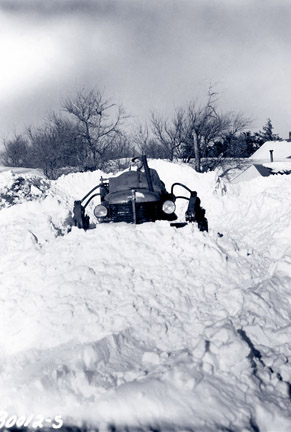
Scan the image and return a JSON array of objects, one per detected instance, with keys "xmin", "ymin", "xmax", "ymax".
[{"xmin": 108, "ymin": 202, "xmax": 159, "ymax": 223}]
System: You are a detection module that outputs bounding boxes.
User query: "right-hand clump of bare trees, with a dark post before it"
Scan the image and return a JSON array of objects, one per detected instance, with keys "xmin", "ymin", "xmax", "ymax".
[{"xmin": 136, "ymin": 91, "xmax": 251, "ymax": 172}]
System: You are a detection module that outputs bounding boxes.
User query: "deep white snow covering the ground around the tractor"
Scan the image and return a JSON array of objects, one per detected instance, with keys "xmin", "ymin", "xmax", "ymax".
[{"xmin": 0, "ymin": 161, "xmax": 291, "ymax": 432}]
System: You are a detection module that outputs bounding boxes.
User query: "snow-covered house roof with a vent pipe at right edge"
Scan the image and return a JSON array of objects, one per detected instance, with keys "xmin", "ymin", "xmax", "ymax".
[{"xmin": 231, "ymin": 141, "xmax": 291, "ymax": 183}]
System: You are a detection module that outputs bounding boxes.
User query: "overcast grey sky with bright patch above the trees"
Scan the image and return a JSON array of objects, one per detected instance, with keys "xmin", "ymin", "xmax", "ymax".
[{"xmin": 0, "ymin": 0, "xmax": 291, "ymax": 147}]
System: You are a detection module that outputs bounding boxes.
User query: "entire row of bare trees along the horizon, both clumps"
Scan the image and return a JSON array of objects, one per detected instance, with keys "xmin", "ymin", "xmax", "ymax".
[{"xmin": 2, "ymin": 88, "xmax": 282, "ymax": 178}]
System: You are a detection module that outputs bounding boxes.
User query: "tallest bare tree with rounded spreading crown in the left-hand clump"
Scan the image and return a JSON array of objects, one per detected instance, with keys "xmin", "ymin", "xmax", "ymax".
[{"xmin": 63, "ymin": 90, "xmax": 126, "ymax": 168}]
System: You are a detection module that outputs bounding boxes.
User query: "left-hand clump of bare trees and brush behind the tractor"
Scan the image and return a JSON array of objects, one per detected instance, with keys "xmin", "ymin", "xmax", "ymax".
[{"xmin": 2, "ymin": 90, "xmax": 131, "ymax": 178}]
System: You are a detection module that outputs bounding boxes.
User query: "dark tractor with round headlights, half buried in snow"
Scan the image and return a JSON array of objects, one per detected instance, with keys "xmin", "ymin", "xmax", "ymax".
[{"xmin": 73, "ymin": 155, "xmax": 208, "ymax": 231}]
